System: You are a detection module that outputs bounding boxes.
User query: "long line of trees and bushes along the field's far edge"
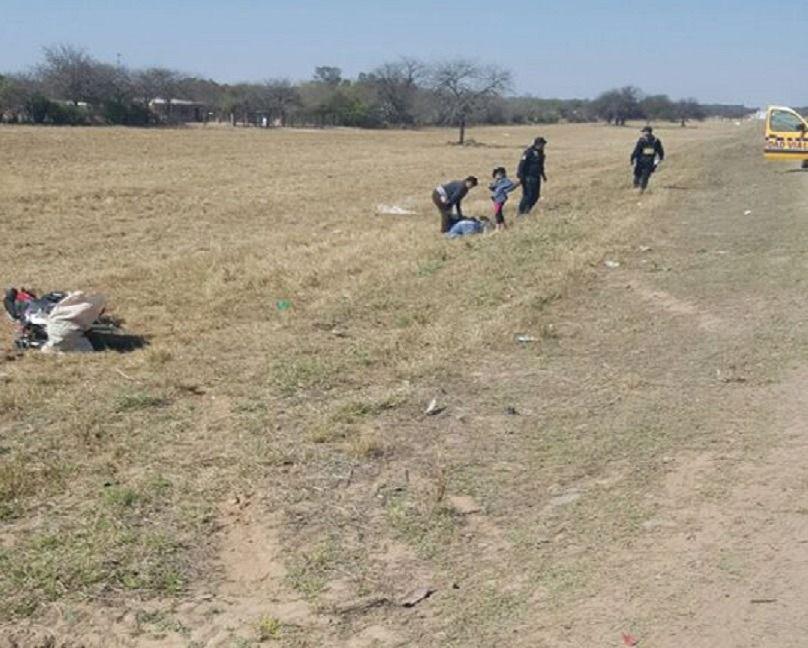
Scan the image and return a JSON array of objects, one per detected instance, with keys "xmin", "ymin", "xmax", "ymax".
[{"xmin": 0, "ymin": 45, "xmax": 752, "ymax": 143}]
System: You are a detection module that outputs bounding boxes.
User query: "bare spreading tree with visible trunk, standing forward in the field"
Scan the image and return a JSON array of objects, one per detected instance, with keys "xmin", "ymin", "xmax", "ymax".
[{"xmin": 430, "ymin": 59, "xmax": 511, "ymax": 144}]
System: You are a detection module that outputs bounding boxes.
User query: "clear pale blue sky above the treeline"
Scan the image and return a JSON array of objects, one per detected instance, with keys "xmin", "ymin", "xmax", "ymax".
[{"xmin": 0, "ymin": 0, "xmax": 808, "ymax": 106}]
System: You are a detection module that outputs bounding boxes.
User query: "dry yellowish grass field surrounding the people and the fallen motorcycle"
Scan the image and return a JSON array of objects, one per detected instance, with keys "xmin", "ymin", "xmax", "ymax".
[{"xmin": 0, "ymin": 123, "xmax": 806, "ymax": 648}]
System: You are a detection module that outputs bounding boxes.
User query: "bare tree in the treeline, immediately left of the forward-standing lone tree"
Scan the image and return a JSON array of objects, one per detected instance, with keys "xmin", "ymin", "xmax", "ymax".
[{"xmin": 360, "ymin": 57, "xmax": 427, "ymax": 124}]
